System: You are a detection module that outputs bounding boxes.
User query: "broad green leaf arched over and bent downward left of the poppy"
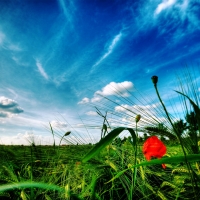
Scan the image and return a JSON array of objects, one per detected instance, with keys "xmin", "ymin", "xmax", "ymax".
[{"xmin": 82, "ymin": 127, "xmax": 136, "ymax": 163}]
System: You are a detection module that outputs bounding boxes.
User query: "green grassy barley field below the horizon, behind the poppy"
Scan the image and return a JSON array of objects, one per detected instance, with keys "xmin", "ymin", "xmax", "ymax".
[{"xmin": 0, "ymin": 141, "xmax": 199, "ymax": 200}]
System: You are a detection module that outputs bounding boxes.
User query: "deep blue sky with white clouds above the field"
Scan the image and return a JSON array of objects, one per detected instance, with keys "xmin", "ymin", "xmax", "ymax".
[{"xmin": 0, "ymin": 0, "xmax": 200, "ymax": 144}]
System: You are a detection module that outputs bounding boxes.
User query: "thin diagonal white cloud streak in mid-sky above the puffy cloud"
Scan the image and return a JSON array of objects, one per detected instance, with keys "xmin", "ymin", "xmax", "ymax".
[{"xmin": 91, "ymin": 33, "xmax": 122, "ymax": 73}]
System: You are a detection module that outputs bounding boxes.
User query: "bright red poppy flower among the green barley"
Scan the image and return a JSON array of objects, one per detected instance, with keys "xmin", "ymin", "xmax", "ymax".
[{"xmin": 142, "ymin": 136, "xmax": 167, "ymax": 169}]
